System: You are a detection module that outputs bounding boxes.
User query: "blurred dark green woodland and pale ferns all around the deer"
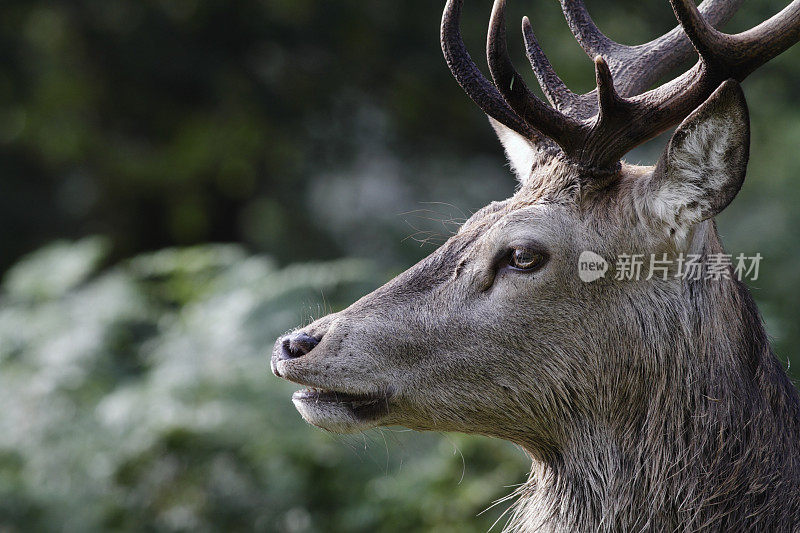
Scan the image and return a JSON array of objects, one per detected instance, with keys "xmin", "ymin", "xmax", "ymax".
[{"xmin": 0, "ymin": 0, "xmax": 800, "ymax": 531}]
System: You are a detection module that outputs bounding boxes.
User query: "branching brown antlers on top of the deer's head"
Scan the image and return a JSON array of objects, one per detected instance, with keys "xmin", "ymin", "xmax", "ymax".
[{"xmin": 442, "ymin": 0, "xmax": 800, "ymax": 169}]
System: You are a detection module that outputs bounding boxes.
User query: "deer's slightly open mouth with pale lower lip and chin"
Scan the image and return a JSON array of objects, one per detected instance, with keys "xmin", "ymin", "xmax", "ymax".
[{"xmin": 292, "ymin": 387, "xmax": 389, "ymax": 433}]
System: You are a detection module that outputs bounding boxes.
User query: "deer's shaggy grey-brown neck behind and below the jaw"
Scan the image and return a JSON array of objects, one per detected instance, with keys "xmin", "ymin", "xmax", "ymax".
[{"xmin": 509, "ymin": 224, "xmax": 800, "ymax": 531}]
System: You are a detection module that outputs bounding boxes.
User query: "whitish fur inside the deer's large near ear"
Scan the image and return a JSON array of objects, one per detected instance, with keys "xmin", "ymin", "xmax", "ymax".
[{"xmin": 643, "ymin": 118, "xmax": 735, "ymax": 240}]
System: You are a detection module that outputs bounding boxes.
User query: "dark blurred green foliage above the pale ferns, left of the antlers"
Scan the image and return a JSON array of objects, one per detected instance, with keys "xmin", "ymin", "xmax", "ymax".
[{"xmin": 0, "ymin": 0, "xmax": 513, "ymax": 269}]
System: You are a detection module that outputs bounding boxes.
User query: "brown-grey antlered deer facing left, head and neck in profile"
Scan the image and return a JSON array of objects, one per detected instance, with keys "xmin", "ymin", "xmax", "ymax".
[{"xmin": 270, "ymin": 0, "xmax": 800, "ymax": 532}]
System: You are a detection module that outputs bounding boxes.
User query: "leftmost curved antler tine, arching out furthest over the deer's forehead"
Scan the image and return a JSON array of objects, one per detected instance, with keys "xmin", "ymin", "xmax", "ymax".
[{"xmin": 441, "ymin": 0, "xmax": 549, "ymax": 144}]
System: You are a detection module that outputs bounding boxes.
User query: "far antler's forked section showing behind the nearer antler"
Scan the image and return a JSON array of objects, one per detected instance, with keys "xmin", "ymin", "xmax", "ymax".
[{"xmin": 561, "ymin": 0, "xmax": 743, "ymax": 96}]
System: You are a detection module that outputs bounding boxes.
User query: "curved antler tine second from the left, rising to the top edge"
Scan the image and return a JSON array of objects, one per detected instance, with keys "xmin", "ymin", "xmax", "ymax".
[{"xmin": 486, "ymin": 0, "xmax": 581, "ymax": 153}]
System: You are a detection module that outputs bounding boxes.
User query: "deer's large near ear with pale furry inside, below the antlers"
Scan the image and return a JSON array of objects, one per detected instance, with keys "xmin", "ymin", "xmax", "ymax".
[{"xmin": 644, "ymin": 80, "xmax": 750, "ymax": 234}]
